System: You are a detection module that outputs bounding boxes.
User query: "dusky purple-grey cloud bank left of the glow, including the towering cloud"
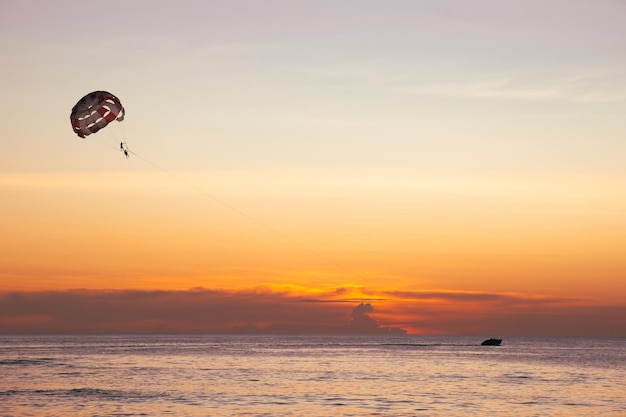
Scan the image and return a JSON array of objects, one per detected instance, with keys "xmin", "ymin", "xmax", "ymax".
[{"xmin": 0, "ymin": 289, "xmax": 404, "ymax": 334}]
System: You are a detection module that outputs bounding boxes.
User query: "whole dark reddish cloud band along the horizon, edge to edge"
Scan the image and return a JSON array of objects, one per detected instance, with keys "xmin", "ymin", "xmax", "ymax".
[{"xmin": 0, "ymin": 288, "xmax": 626, "ymax": 337}]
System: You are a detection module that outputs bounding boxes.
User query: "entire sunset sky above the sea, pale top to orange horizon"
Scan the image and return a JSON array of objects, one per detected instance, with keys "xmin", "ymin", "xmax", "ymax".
[{"xmin": 0, "ymin": 0, "xmax": 626, "ymax": 337}]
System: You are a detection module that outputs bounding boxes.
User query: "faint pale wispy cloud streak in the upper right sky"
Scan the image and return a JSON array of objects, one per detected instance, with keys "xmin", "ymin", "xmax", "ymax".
[{"xmin": 303, "ymin": 58, "xmax": 626, "ymax": 104}]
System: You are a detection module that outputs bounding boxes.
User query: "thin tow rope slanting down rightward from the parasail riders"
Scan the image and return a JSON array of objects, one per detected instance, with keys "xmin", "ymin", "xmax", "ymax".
[{"xmin": 120, "ymin": 146, "xmax": 346, "ymax": 275}]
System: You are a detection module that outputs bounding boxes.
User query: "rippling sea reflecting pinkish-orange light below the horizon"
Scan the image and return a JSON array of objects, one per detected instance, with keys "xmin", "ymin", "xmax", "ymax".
[{"xmin": 0, "ymin": 336, "xmax": 626, "ymax": 417}]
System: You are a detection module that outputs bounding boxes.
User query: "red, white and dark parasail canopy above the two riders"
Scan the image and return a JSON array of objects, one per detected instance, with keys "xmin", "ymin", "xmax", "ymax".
[{"xmin": 70, "ymin": 91, "xmax": 124, "ymax": 139}]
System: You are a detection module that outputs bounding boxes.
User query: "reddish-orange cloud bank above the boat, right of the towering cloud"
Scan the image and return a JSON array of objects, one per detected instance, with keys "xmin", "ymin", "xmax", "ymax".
[{"xmin": 387, "ymin": 291, "xmax": 626, "ymax": 337}]
